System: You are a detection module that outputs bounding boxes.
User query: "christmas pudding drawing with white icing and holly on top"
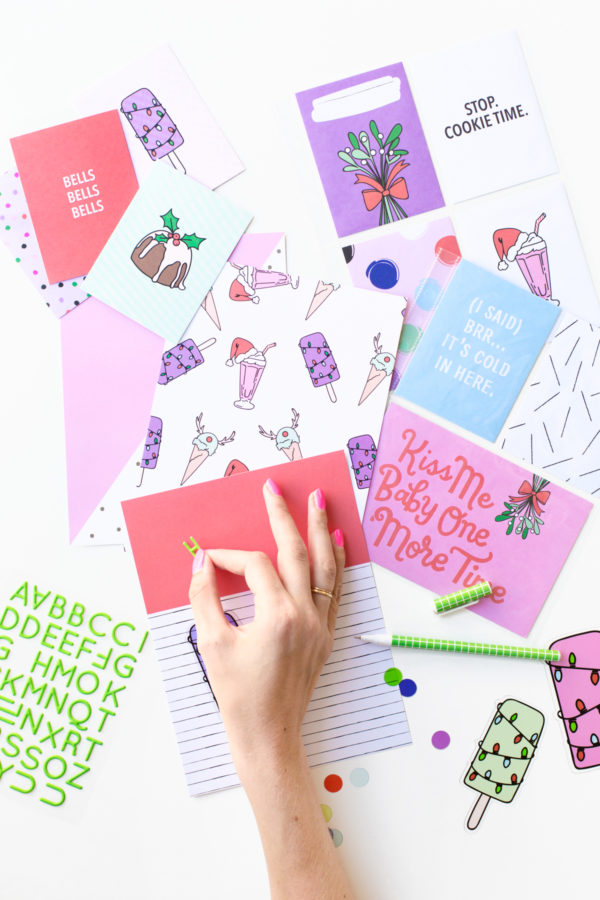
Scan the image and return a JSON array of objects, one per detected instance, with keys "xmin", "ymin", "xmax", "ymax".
[{"xmin": 131, "ymin": 209, "xmax": 205, "ymax": 291}]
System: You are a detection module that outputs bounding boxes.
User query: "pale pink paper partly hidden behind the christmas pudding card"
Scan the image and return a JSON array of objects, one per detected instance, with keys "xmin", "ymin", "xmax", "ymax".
[{"xmin": 60, "ymin": 232, "xmax": 283, "ymax": 542}]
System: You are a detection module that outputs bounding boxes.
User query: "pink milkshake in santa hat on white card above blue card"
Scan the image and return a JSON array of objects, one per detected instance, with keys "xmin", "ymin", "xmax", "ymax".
[{"xmin": 493, "ymin": 213, "xmax": 560, "ymax": 306}]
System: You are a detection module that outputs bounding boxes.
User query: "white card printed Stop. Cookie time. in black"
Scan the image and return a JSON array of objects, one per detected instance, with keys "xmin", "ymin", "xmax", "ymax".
[{"xmin": 406, "ymin": 32, "xmax": 556, "ymax": 204}]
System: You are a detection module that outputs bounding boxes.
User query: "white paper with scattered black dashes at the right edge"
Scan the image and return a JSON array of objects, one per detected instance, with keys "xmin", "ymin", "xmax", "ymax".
[{"xmin": 500, "ymin": 315, "xmax": 600, "ymax": 495}]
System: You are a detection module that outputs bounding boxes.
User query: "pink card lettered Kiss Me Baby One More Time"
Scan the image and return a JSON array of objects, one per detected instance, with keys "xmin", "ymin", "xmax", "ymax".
[{"xmin": 363, "ymin": 403, "xmax": 592, "ymax": 636}]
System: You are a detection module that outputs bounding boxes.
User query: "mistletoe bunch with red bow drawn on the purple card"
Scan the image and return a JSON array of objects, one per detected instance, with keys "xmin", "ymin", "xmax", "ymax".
[{"xmin": 338, "ymin": 119, "xmax": 410, "ymax": 225}]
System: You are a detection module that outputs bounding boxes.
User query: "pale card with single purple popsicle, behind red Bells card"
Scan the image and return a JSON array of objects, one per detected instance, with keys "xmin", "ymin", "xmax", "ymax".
[{"xmin": 78, "ymin": 45, "xmax": 244, "ymax": 188}]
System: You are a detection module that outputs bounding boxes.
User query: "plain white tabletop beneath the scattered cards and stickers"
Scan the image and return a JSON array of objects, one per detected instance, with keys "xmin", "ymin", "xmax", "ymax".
[{"xmin": 0, "ymin": 0, "xmax": 600, "ymax": 900}]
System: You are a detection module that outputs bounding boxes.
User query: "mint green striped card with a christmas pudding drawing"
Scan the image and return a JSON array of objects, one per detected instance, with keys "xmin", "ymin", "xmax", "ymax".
[{"xmin": 86, "ymin": 165, "xmax": 252, "ymax": 346}]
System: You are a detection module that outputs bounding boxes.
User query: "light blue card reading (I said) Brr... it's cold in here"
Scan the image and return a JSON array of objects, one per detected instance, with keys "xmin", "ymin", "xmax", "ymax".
[{"xmin": 396, "ymin": 260, "xmax": 559, "ymax": 441}]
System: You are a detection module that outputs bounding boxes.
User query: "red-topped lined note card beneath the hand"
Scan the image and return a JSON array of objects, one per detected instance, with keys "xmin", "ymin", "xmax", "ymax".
[{"xmin": 124, "ymin": 451, "xmax": 410, "ymax": 795}]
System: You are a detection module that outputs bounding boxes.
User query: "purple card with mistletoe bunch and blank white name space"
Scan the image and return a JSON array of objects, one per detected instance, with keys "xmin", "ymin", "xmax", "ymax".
[{"xmin": 296, "ymin": 63, "xmax": 444, "ymax": 237}]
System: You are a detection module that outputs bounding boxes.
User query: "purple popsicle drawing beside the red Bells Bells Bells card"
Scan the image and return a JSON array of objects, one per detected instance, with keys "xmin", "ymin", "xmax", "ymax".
[{"xmin": 121, "ymin": 88, "xmax": 186, "ymax": 174}]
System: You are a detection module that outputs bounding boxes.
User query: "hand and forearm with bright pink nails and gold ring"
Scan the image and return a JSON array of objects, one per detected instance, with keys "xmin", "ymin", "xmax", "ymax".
[{"xmin": 190, "ymin": 479, "xmax": 353, "ymax": 900}]
